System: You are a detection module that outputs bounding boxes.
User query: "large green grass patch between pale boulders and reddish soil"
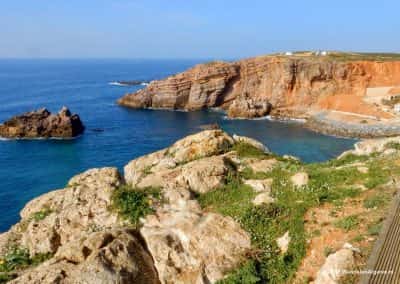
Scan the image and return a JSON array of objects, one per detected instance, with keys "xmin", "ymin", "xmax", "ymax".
[{"xmin": 198, "ymin": 151, "xmax": 396, "ymax": 283}]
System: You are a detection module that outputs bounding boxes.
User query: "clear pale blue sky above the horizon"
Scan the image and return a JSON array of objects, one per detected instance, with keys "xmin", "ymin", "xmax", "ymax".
[{"xmin": 0, "ymin": 0, "xmax": 400, "ymax": 59}]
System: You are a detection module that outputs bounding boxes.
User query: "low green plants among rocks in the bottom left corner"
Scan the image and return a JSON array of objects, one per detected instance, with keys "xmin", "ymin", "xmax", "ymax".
[{"xmin": 0, "ymin": 247, "xmax": 53, "ymax": 283}]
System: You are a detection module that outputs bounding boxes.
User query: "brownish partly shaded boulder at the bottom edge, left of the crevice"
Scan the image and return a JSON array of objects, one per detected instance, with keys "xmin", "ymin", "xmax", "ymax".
[{"xmin": 11, "ymin": 229, "xmax": 159, "ymax": 284}]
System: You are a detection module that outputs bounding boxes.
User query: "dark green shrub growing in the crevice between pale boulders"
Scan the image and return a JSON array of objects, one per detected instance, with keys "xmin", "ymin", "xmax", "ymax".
[{"xmin": 111, "ymin": 185, "xmax": 161, "ymax": 226}]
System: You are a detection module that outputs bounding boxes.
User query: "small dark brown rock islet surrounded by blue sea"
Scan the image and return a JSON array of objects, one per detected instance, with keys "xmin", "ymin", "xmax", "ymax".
[{"xmin": 0, "ymin": 107, "xmax": 85, "ymax": 138}]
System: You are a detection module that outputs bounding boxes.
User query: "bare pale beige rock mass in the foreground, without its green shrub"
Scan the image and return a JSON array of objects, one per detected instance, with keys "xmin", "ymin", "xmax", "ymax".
[{"xmin": 0, "ymin": 130, "xmax": 260, "ymax": 284}]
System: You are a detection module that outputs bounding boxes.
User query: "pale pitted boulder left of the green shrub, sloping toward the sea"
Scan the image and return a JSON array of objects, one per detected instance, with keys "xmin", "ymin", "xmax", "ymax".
[{"xmin": 10, "ymin": 168, "xmax": 122, "ymax": 255}]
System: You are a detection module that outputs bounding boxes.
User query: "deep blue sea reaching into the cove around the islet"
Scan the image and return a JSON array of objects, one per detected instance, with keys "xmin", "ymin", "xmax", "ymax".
[{"xmin": 0, "ymin": 59, "xmax": 355, "ymax": 232}]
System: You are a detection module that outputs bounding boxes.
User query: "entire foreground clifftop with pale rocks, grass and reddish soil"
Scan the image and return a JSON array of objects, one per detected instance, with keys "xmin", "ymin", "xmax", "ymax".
[{"xmin": 0, "ymin": 130, "xmax": 400, "ymax": 284}]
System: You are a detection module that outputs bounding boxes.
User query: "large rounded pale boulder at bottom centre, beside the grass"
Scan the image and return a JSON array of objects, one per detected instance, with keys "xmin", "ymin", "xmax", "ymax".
[{"xmin": 140, "ymin": 201, "xmax": 250, "ymax": 284}]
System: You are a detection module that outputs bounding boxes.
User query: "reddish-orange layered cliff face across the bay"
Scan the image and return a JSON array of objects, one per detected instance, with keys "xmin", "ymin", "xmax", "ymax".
[{"xmin": 118, "ymin": 56, "xmax": 400, "ymax": 117}]
